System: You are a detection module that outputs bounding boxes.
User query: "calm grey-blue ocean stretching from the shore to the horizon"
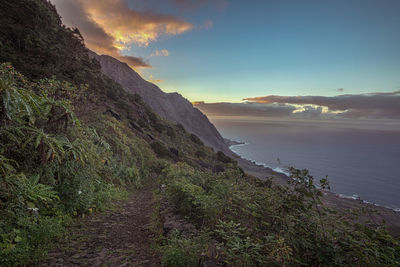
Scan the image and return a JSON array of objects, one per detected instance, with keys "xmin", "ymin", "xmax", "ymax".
[{"xmin": 210, "ymin": 117, "xmax": 400, "ymax": 211}]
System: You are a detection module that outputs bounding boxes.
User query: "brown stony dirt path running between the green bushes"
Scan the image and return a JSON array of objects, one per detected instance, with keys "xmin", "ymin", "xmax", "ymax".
[{"xmin": 40, "ymin": 186, "xmax": 160, "ymax": 266}]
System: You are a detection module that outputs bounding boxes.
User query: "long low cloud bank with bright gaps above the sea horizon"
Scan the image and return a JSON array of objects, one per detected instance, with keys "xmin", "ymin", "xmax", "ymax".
[{"xmin": 194, "ymin": 91, "xmax": 400, "ymax": 119}]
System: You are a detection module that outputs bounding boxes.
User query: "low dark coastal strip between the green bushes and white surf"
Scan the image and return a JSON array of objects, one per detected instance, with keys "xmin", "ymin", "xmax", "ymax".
[{"xmin": 227, "ymin": 140, "xmax": 400, "ymax": 237}]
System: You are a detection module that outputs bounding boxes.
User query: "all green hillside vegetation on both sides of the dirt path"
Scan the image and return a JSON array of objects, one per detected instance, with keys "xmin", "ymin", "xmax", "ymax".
[{"xmin": 0, "ymin": 0, "xmax": 400, "ymax": 266}]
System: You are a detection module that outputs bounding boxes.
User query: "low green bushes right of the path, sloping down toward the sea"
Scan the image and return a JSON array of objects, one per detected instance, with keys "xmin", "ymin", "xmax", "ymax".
[{"xmin": 162, "ymin": 163, "xmax": 400, "ymax": 266}]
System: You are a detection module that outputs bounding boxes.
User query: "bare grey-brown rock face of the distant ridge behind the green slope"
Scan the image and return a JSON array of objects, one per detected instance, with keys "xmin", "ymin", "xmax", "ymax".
[{"xmin": 91, "ymin": 52, "xmax": 230, "ymax": 153}]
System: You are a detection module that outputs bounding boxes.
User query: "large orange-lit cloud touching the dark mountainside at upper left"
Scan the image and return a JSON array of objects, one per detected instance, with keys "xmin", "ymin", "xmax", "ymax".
[{"xmin": 51, "ymin": 0, "xmax": 194, "ymax": 68}]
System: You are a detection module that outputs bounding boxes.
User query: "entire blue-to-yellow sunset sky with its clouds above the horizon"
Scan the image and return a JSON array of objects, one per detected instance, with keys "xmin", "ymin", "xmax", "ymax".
[{"xmin": 51, "ymin": 0, "xmax": 400, "ymax": 119}]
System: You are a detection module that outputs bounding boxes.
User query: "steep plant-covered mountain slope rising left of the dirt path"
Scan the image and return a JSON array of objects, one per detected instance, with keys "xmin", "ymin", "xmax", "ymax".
[{"xmin": 0, "ymin": 0, "xmax": 238, "ymax": 266}]
